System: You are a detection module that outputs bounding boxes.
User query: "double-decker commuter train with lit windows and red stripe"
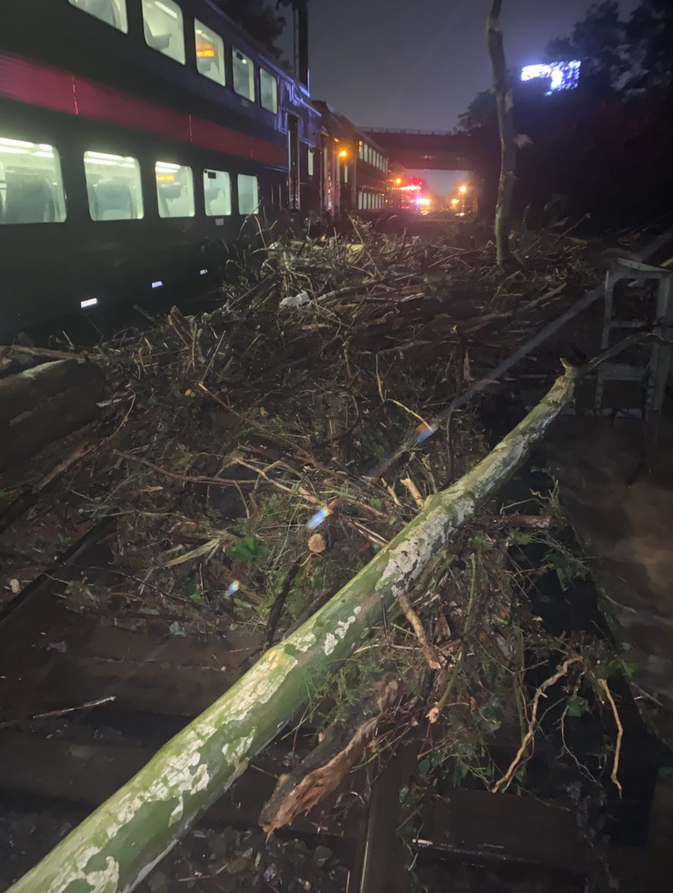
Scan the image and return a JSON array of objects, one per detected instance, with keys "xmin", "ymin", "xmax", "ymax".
[{"xmin": 0, "ymin": 0, "xmax": 389, "ymax": 338}]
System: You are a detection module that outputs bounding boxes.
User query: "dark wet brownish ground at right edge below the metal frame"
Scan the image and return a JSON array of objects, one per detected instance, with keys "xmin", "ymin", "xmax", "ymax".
[{"xmin": 547, "ymin": 417, "xmax": 673, "ymax": 740}]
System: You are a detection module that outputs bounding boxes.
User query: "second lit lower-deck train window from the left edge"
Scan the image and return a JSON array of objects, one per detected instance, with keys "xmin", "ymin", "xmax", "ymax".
[{"xmin": 84, "ymin": 152, "xmax": 145, "ymax": 221}]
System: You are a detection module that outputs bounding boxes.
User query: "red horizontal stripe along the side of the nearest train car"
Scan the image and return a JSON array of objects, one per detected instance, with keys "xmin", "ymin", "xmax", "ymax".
[{"xmin": 0, "ymin": 52, "xmax": 286, "ymax": 167}]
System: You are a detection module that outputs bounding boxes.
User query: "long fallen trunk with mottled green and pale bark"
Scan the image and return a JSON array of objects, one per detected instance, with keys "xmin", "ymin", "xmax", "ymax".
[{"xmin": 5, "ymin": 369, "xmax": 577, "ymax": 893}]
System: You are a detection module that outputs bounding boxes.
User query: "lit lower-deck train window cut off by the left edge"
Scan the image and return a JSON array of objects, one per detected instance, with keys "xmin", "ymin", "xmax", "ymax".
[{"xmin": 0, "ymin": 138, "xmax": 66, "ymax": 225}]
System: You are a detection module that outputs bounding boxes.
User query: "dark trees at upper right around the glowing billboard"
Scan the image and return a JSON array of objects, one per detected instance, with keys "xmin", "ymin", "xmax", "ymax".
[{"xmin": 460, "ymin": 0, "xmax": 673, "ymax": 229}]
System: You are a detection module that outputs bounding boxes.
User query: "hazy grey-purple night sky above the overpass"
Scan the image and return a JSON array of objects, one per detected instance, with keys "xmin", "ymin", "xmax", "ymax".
[{"xmin": 302, "ymin": 0, "xmax": 637, "ymax": 130}]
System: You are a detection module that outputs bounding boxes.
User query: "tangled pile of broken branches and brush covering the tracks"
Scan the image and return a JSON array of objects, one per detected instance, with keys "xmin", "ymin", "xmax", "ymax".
[{"xmin": 3, "ymin": 224, "xmax": 636, "ymax": 889}]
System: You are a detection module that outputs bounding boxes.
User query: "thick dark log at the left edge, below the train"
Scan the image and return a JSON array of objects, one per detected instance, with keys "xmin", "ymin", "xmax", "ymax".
[{"xmin": 0, "ymin": 360, "xmax": 105, "ymax": 472}]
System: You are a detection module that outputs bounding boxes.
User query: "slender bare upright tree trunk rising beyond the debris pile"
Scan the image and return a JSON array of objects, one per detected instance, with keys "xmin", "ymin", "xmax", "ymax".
[{"xmin": 486, "ymin": 0, "xmax": 516, "ymax": 266}]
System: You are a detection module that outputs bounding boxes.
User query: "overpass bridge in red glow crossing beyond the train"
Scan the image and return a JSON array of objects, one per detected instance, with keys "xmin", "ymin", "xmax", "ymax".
[{"xmin": 362, "ymin": 127, "xmax": 480, "ymax": 171}]
